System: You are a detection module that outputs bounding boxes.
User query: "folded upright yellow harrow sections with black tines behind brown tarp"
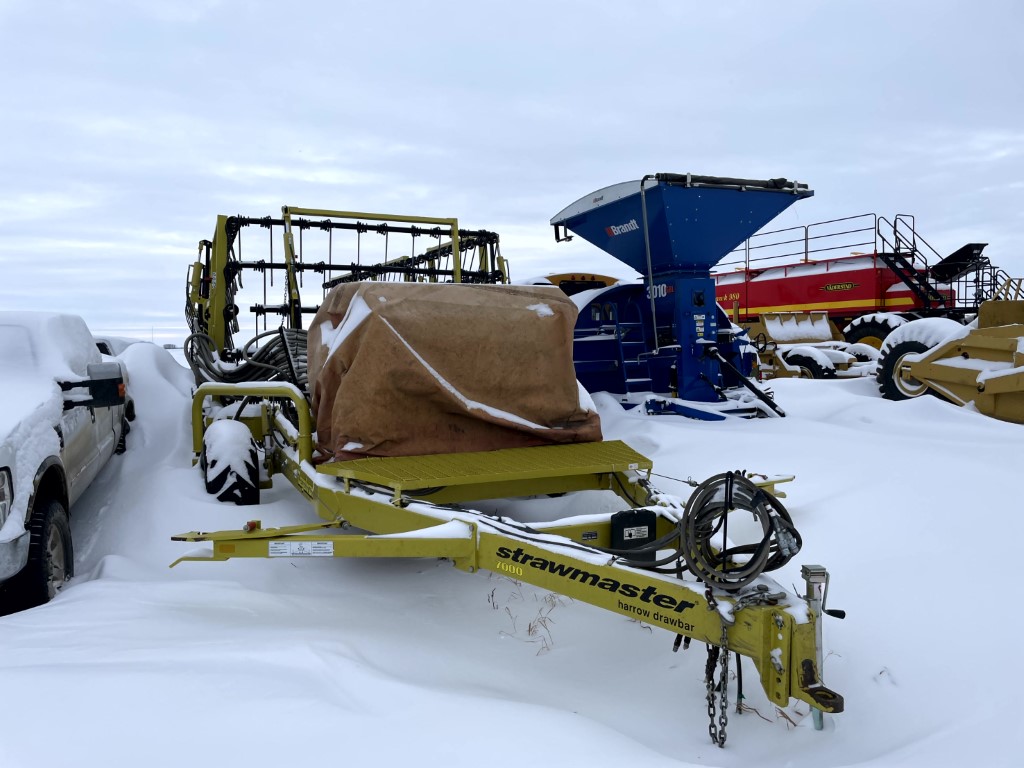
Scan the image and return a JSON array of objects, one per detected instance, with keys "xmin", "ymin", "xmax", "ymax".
[{"xmin": 184, "ymin": 206, "xmax": 509, "ymax": 390}]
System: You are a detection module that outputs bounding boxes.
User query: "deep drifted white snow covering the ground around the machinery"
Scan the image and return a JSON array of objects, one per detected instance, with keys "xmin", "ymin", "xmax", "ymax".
[{"xmin": 0, "ymin": 344, "xmax": 1024, "ymax": 768}]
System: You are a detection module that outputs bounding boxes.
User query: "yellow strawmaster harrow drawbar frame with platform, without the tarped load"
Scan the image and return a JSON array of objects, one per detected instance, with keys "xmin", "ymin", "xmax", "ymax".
[{"xmin": 174, "ymin": 383, "xmax": 843, "ymax": 743}]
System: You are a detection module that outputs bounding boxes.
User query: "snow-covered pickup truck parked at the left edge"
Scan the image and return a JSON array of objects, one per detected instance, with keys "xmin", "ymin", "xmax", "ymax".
[{"xmin": 0, "ymin": 312, "xmax": 134, "ymax": 610}]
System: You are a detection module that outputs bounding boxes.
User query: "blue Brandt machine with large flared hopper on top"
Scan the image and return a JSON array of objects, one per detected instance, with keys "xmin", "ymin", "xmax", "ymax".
[{"xmin": 551, "ymin": 173, "xmax": 814, "ymax": 420}]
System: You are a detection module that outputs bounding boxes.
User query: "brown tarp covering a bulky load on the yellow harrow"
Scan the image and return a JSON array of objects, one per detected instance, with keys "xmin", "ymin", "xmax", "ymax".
[{"xmin": 308, "ymin": 283, "xmax": 601, "ymax": 461}]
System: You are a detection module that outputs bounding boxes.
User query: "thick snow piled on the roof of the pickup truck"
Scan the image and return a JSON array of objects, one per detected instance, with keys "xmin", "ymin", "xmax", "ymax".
[{"xmin": 0, "ymin": 311, "xmax": 102, "ymax": 380}]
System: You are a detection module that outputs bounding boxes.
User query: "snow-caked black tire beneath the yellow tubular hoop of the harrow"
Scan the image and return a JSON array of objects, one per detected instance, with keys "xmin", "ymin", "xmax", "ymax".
[{"xmin": 200, "ymin": 419, "xmax": 259, "ymax": 505}]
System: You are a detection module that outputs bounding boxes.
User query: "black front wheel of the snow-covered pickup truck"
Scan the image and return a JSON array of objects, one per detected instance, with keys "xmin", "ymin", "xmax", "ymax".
[{"xmin": 16, "ymin": 500, "xmax": 75, "ymax": 608}]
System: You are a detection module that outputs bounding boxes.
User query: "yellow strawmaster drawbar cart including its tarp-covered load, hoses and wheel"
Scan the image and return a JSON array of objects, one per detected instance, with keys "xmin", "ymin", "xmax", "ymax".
[{"xmin": 175, "ymin": 204, "xmax": 844, "ymax": 746}]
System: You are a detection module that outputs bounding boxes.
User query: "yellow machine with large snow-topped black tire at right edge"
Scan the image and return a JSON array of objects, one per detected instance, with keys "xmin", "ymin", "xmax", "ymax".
[{"xmin": 878, "ymin": 280, "xmax": 1024, "ymax": 424}]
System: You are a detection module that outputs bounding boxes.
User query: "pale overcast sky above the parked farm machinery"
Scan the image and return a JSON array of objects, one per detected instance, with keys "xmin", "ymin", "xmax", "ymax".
[{"xmin": 0, "ymin": 0, "xmax": 1024, "ymax": 342}]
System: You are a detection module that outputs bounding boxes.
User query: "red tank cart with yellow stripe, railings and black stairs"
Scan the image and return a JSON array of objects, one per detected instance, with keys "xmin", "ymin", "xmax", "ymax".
[{"xmin": 713, "ymin": 214, "xmax": 1006, "ymax": 346}]
